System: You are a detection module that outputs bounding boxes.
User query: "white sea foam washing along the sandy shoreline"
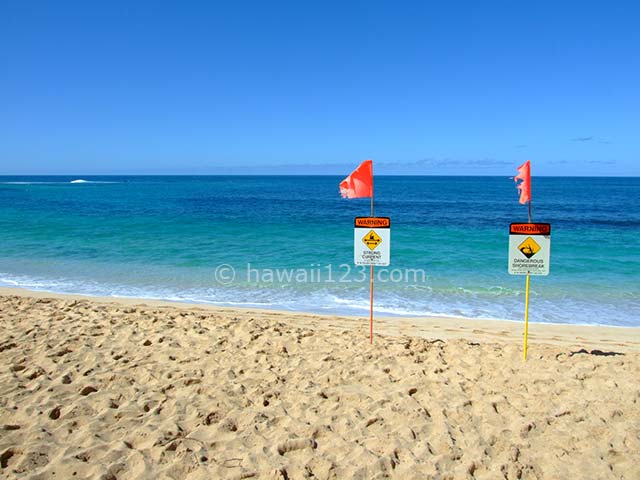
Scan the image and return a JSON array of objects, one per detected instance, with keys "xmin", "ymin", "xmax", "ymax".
[{"xmin": 0, "ymin": 272, "xmax": 637, "ymax": 326}]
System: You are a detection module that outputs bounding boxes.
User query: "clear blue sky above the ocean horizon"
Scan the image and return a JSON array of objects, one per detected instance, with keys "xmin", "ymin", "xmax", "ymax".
[{"xmin": 0, "ymin": 0, "xmax": 640, "ymax": 176}]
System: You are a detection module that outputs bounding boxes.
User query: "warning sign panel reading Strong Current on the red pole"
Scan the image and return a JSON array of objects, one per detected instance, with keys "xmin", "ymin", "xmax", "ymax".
[{"xmin": 353, "ymin": 217, "xmax": 391, "ymax": 266}]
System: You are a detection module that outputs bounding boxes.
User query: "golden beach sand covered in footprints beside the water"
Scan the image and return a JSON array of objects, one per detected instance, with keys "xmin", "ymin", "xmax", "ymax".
[{"xmin": 0, "ymin": 289, "xmax": 640, "ymax": 479}]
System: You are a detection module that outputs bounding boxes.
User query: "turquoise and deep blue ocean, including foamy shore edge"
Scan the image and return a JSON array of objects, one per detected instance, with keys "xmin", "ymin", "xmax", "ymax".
[{"xmin": 0, "ymin": 172, "xmax": 640, "ymax": 326}]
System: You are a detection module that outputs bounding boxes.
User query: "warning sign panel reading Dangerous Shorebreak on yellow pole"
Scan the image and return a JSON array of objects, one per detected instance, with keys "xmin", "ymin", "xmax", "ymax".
[{"xmin": 509, "ymin": 223, "xmax": 551, "ymax": 275}]
